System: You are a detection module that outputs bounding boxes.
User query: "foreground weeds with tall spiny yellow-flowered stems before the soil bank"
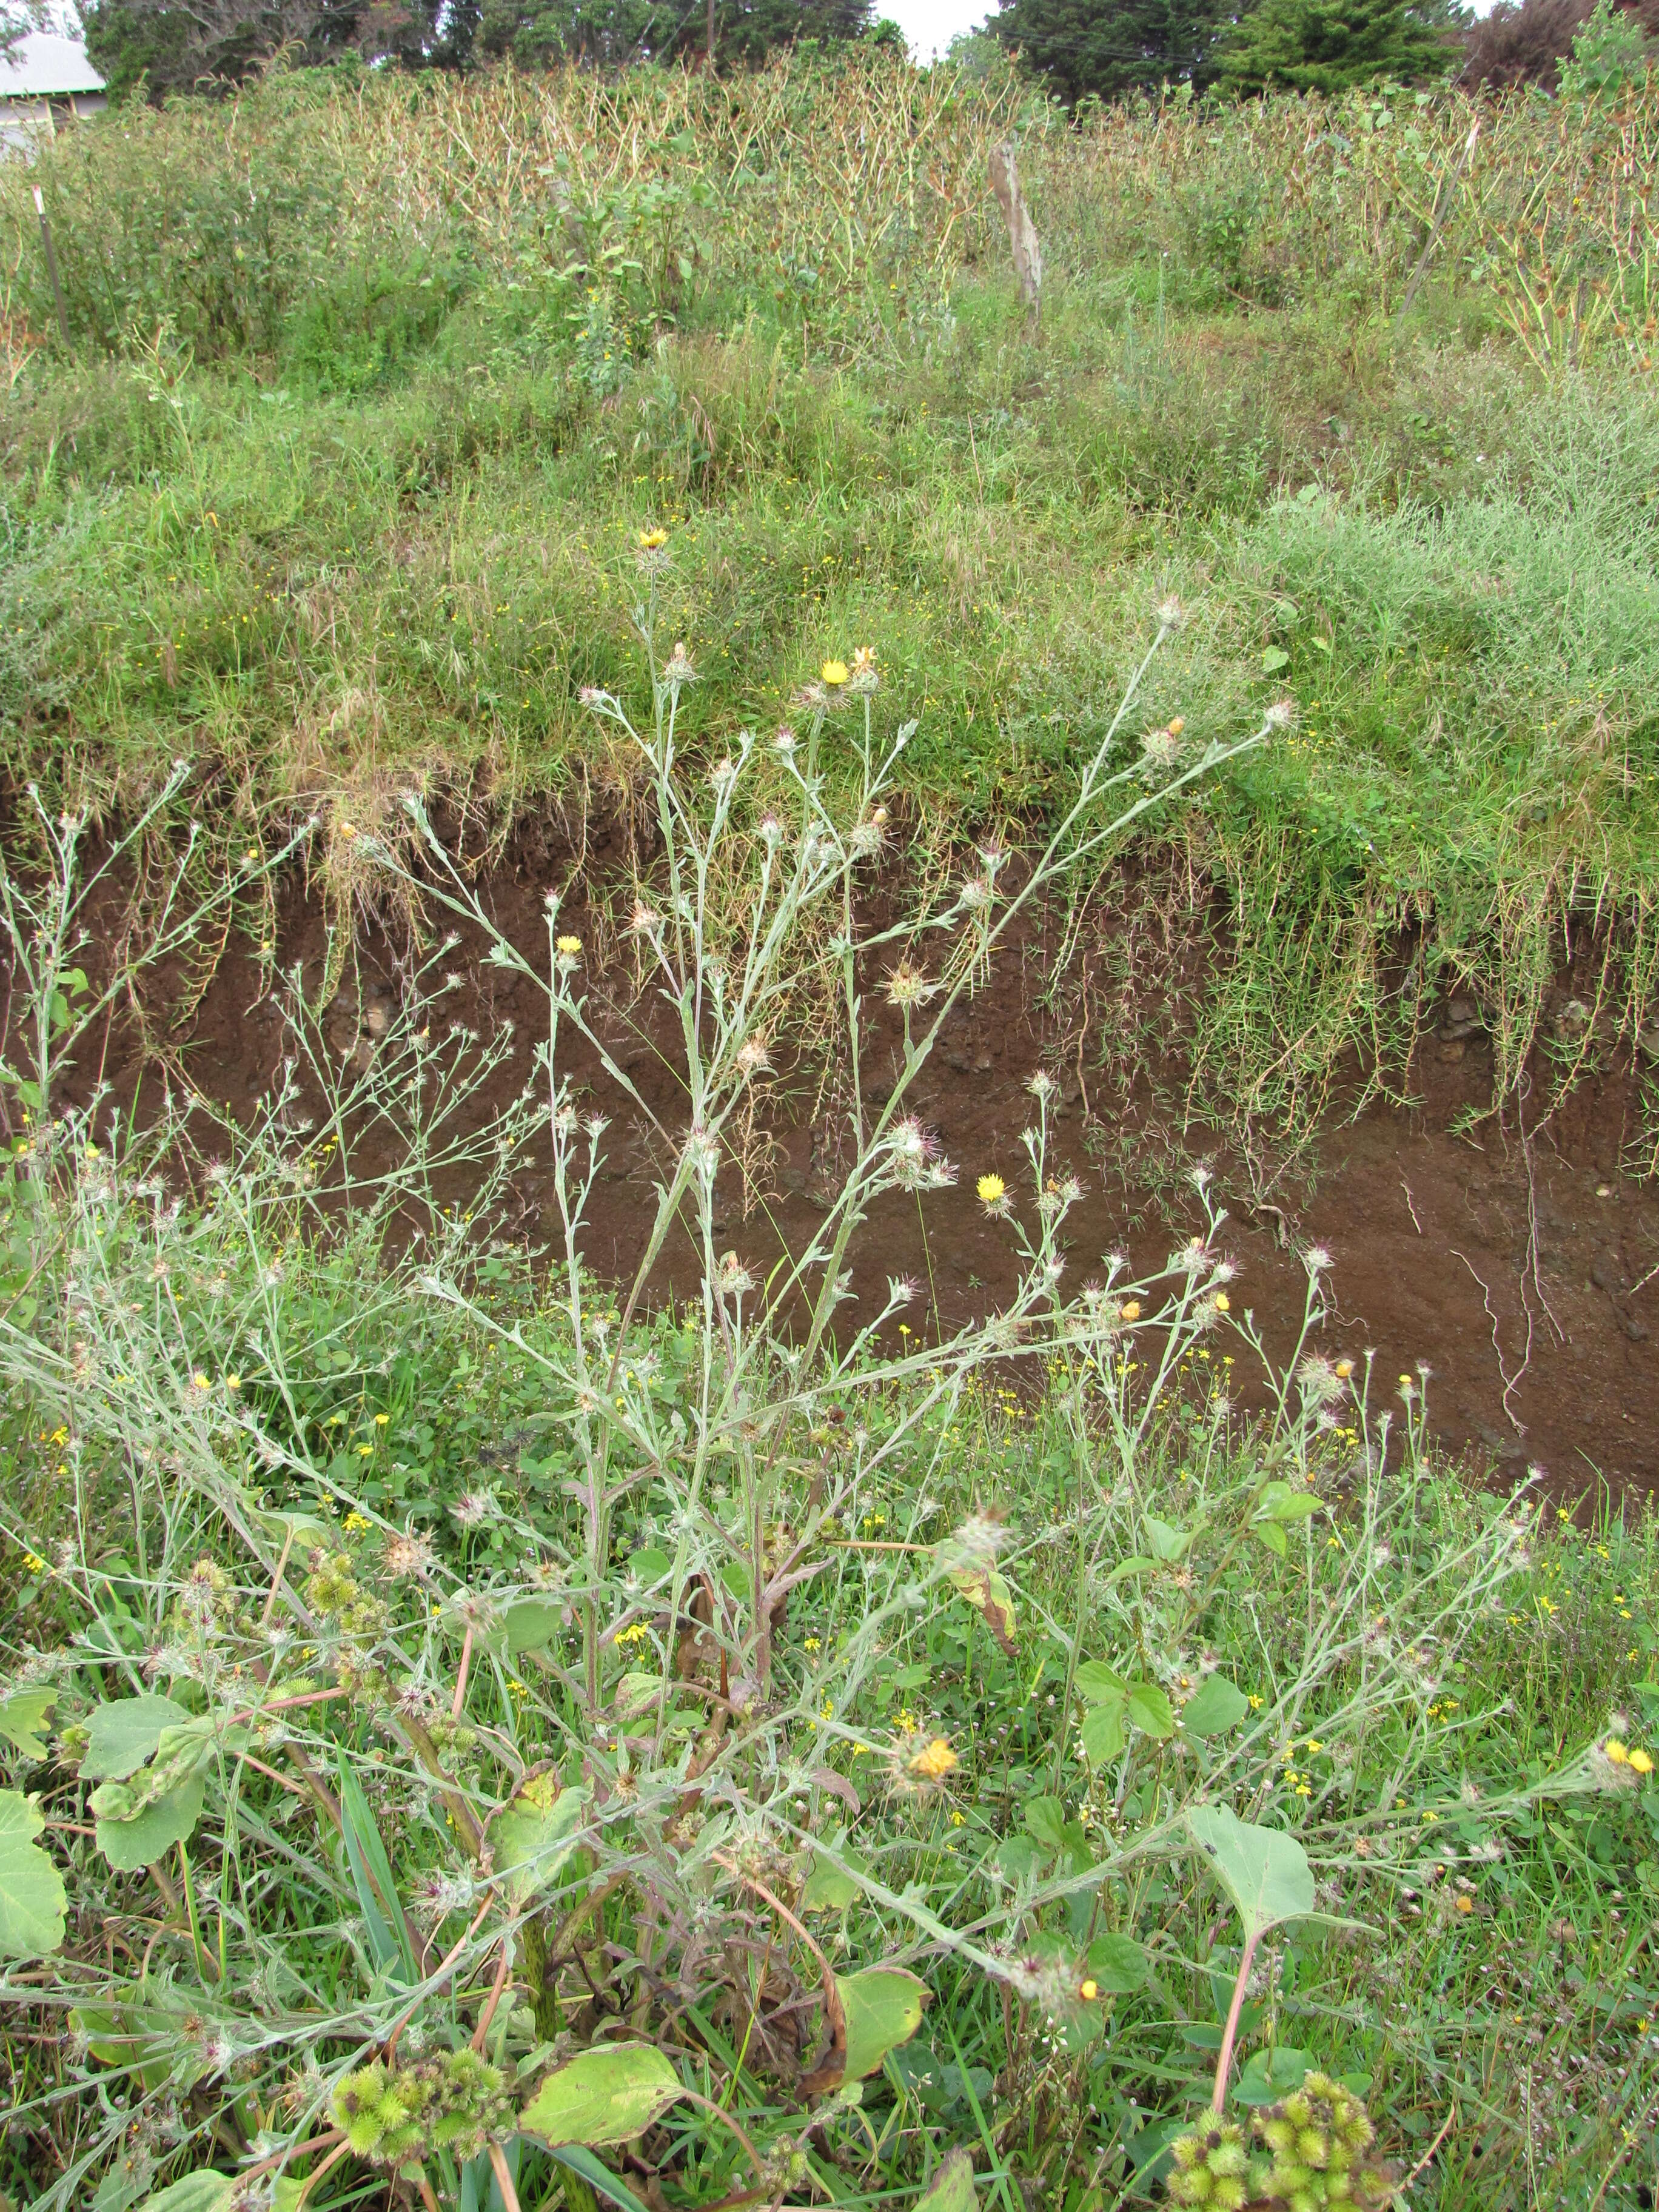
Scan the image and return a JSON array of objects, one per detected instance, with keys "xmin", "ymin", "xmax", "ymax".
[{"xmin": 0, "ymin": 606, "xmax": 1659, "ymax": 2212}]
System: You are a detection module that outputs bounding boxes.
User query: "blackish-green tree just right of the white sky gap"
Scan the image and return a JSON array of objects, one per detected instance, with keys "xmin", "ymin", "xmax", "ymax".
[{"xmin": 987, "ymin": 0, "xmax": 1235, "ymax": 104}]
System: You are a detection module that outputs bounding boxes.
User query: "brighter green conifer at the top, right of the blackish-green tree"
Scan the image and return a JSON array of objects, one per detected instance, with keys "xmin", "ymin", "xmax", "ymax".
[{"xmin": 1216, "ymin": 0, "xmax": 1464, "ymax": 93}]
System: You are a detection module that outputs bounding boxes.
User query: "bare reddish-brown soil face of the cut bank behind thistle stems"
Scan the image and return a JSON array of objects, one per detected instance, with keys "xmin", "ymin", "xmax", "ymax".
[{"xmin": 25, "ymin": 832, "xmax": 1659, "ymax": 1498}]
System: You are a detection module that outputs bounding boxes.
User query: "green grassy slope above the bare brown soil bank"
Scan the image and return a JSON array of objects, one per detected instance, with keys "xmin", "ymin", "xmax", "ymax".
[{"xmin": 0, "ymin": 71, "xmax": 1659, "ymax": 1130}]
